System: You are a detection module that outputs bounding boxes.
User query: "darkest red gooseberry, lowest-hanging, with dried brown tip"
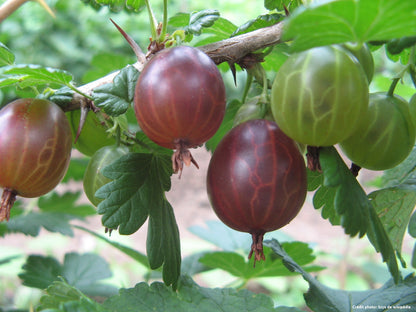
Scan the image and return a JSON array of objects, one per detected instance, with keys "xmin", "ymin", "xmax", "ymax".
[{"xmin": 207, "ymin": 120, "xmax": 306, "ymax": 263}]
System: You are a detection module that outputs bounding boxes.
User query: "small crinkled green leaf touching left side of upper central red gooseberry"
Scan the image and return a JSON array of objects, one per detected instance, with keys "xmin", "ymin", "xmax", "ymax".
[{"xmin": 93, "ymin": 66, "xmax": 139, "ymax": 116}]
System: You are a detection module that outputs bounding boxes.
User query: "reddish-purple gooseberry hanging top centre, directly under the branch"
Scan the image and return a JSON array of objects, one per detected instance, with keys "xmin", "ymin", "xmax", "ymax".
[{"xmin": 134, "ymin": 46, "xmax": 225, "ymax": 178}]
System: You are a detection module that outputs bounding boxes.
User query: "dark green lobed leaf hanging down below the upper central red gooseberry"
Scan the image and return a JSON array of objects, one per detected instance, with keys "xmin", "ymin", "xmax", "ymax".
[{"xmin": 96, "ymin": 153, "xmax": 181, "ymax": 287}]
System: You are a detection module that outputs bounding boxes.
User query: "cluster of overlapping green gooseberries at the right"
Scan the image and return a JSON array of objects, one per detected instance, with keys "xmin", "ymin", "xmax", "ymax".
[{"xmin": 271, "ymin": 45, "xmax": 415, "ymax": 170}]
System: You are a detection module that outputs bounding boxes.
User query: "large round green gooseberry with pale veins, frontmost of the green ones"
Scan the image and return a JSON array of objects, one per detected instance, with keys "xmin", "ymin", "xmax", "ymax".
[{"xmin": 271, "ymin": 46, "xmax": 369, "ymax": 146}]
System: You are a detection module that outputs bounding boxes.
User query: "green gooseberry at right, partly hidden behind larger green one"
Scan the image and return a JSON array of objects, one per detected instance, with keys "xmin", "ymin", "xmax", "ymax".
[{"xmin": 339, "ymin": 92, "xmax": 416, "ymax": 170}]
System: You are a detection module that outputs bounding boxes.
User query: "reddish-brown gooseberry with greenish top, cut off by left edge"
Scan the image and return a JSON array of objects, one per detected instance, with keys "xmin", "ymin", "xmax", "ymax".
[{"xmin": 0, "ymin": 99, "xmax": 72, "ymax": 221}]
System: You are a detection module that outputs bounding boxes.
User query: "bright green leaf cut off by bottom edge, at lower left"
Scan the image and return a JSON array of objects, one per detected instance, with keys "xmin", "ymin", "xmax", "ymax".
[{"xmin": 37, "ymin": 281, "xmax": 106, "ymax": 312}]
